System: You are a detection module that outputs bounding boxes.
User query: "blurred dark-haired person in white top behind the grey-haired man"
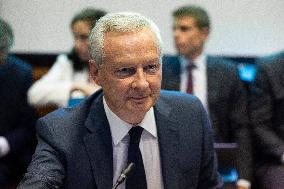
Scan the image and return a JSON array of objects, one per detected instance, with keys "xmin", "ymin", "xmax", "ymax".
[{"xmin": 28, "ymin": 8, "xmax": 106, "ymax": 107}]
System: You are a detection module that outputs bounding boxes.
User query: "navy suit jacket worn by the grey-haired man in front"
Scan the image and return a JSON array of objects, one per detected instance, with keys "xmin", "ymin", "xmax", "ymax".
[{"xmin": 18, "ymin": 91, "xmax": 223, "ymax": 189}]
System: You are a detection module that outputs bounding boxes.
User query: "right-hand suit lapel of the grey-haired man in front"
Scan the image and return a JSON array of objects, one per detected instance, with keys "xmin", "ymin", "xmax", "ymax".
[{"xmin": 154, "ymin": 100, "xmax": 180, "ymax": 189}]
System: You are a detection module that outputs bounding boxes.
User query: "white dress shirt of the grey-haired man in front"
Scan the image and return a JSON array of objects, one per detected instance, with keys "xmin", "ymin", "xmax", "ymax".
[{"xmin": 104, "ymin": 99, "xmax": 164, "ymax": 189}]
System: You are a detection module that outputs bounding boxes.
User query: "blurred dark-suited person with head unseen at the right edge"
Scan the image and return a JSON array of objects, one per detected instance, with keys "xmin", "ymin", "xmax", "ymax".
[{"xmin": 250, "ymin": 51, "xmax": 284, "ymax": 189}]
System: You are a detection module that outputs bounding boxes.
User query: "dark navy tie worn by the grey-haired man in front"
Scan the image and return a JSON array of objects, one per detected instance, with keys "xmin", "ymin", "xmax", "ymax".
[{"xmin": 125, "ymin": 126, "xmax": 147, "ymax": 189}]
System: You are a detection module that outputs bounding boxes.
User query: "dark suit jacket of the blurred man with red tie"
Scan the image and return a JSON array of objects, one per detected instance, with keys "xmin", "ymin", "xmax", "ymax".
[{"xmin": 162, "ymin": 56, "xmax": 252, "ymax": 180}]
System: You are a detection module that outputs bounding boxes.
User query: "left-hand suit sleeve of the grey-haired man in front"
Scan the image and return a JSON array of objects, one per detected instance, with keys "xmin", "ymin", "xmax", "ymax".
[{"xmin": 17, "ymin": 119, "xmax": 65, "ymax": 189}]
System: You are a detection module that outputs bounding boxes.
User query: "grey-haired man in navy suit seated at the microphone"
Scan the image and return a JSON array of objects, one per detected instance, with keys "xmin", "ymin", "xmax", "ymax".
[{"xmin": 18, "ymin": 13, "xmax": 222, "ymax": 189}]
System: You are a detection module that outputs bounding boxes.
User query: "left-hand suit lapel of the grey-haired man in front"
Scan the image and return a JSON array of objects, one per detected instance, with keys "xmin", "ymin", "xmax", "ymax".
[{"xmin": 84, "ymin": 94, "xmax": 113, "ymax": 189}]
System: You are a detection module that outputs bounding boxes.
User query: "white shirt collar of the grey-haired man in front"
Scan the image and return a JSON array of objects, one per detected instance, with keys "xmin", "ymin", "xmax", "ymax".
[{"xmin": 103, "ymin": 98, "xmax": 157, "ymax": 145}]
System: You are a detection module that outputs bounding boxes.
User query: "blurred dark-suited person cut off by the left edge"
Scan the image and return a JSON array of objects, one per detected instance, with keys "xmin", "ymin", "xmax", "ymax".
[{"xmin": 0, "ymin": 19, "xmax": 36, "ymax": 189}]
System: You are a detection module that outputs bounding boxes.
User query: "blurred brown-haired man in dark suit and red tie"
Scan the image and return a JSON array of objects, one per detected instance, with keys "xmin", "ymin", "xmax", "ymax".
[{"xmin": 162, "ymin": 6, "xmax": 251, "ymax": 188}]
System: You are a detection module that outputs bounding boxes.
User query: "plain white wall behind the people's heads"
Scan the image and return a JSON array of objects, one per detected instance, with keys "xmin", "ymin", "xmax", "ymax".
[{"xmin": 0, "ymin": 0, "xmax": 284, "ymax": 56}]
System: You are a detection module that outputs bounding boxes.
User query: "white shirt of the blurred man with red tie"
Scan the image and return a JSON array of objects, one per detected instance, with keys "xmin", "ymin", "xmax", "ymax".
[{"xmin": 179, "ymin": 54, "xmax": 208, "ymax": 110}]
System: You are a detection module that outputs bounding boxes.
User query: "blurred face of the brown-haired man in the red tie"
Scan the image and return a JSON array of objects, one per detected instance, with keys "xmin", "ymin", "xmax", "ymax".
[{"xmin": 174, "ymin": 16, "xmax": 208, "ymax": 58}]
